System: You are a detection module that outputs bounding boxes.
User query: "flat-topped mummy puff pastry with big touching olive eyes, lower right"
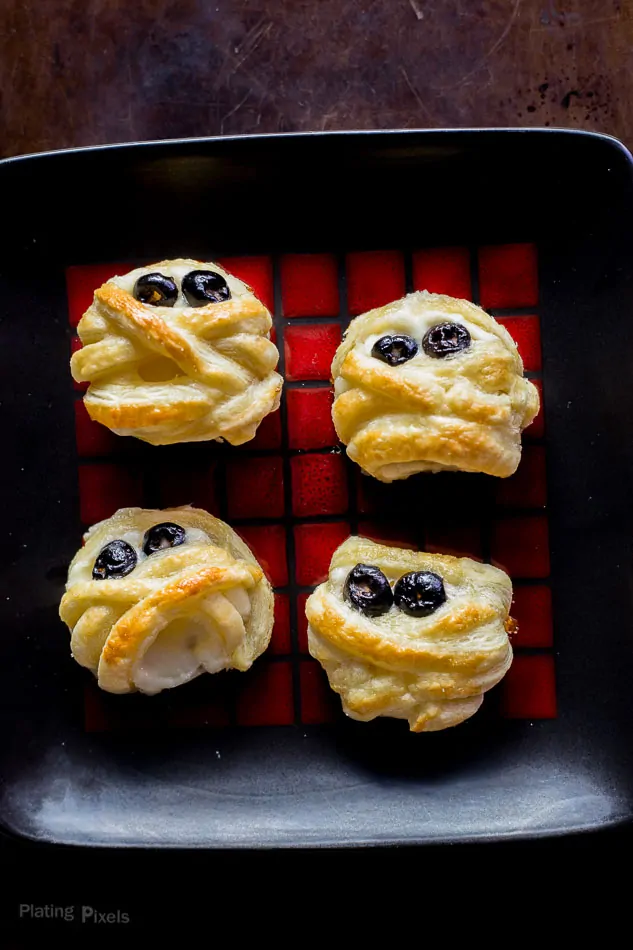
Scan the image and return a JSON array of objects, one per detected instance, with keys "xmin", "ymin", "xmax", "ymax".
[{"xmin": 306, "ymin": 537, "xmax": 514, "ymax": 732}]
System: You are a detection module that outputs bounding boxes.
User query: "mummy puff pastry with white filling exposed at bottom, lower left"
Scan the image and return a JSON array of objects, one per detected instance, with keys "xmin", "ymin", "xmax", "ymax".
[{"xmin": 59, "ymin": 507, "xmax": 273, "ymax": 694}]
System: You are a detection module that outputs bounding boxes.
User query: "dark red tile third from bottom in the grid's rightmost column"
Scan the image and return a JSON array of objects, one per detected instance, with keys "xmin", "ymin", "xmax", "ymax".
[{"xmin": 491, "ymin": 515, "xmax": 550, "ymax": 577}]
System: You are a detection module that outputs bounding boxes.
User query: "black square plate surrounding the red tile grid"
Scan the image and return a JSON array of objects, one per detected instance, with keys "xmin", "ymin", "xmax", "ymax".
[{"xmin": 0, "ymin": 130, "xmax": 633, "ymax": 847}]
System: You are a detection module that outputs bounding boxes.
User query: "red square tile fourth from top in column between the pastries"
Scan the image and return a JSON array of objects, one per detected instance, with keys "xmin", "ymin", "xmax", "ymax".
[{"xmin": 290, "ymin": 452, "xmax": 349, "ymax": 518}]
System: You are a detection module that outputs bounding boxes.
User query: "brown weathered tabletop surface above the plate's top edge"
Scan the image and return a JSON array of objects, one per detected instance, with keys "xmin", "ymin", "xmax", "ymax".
[{"xmin": 0, "ymin": 0, "xmax": 633, "ymax": 155}]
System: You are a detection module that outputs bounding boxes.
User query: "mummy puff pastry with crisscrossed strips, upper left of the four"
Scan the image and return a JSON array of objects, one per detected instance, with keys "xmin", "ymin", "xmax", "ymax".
[{"xmin": 70, "ymin": 260, "xmax": 282, "ymax": 445}]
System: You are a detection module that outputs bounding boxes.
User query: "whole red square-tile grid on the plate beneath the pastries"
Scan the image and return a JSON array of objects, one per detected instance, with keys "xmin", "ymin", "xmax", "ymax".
[{"xmin": 67, "ymin": 244, "xmax": 556, "ymax": 731}]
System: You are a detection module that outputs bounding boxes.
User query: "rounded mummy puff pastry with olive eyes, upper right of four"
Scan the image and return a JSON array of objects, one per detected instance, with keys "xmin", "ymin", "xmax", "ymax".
[{"xmin": 332, "ymin": 291, "xmax": 539, "ymax": 482}]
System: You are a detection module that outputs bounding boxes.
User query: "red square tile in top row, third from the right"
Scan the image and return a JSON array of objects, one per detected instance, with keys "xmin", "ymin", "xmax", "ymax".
[{"xmin": 346, "ymin": 251, "xmax": 406, "ymax": 317}]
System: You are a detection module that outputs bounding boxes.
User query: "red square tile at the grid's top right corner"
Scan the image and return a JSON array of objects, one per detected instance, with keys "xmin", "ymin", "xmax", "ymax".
[{"xmin": 479, "ymin": 244, "xmax": 538, "ymax": 308}]
